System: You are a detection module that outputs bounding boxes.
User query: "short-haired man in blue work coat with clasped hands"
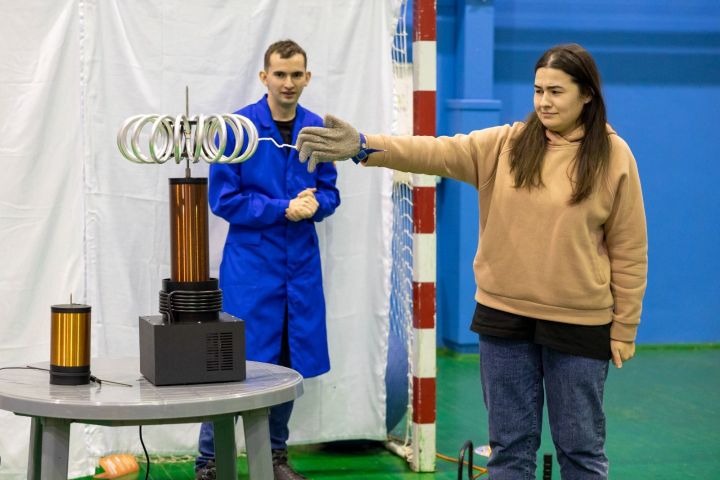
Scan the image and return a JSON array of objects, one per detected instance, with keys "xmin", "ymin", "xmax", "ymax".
[{"xmin": 195, "ymin": 40, "xmax": 340, "ymax": 480}]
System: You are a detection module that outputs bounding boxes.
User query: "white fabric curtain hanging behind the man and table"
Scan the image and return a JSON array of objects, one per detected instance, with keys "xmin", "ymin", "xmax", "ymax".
[{"xmin": 0, "ymin": 0, "xmax": 399, "ymax": 479}]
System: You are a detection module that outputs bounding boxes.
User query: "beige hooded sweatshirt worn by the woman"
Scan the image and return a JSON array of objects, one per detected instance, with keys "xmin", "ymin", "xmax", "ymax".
[{"xmin": 367, "ymin": 123, "xmax": 647, "ymax": 342}]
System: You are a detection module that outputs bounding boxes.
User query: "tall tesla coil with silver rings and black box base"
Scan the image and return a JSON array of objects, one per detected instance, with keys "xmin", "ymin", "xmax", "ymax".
[{"xmin": 117, "ymin": 88, "xmax": 257, "ymax": 385}]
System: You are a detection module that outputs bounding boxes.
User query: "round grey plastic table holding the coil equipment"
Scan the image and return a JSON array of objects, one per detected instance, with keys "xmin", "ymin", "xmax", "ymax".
[{"xmin": 0, "ymin": 357, "xmax": 303, "ymax": 480}]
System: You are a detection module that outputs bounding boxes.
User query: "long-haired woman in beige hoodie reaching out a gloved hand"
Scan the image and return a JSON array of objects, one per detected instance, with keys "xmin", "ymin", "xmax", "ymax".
[{"xmin": 297, "ymin": 44, "xmax": 647, "ymax": 480}]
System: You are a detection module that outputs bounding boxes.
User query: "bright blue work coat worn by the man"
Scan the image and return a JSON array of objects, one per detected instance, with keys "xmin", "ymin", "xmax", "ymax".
[{"xmin": 208, "ymin": 95, "xmax": 340, "ymax": 378}]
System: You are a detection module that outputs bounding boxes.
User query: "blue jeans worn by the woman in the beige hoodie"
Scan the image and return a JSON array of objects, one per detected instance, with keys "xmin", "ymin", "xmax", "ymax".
[{"xmin": 480, "ymin": 335, "xmax": 609, "ymax": 480}]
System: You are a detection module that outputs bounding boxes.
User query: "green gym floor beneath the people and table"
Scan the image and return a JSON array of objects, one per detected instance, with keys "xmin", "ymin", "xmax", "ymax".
[{"xmin": 76, "ymin": 345, "xmax": 720, "ymax": 480}]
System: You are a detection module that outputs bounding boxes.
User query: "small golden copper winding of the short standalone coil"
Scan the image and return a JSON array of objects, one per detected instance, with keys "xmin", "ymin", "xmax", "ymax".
[{"xmin": 50, "ymin": 303, "xmax": 90, "ymax": 367}]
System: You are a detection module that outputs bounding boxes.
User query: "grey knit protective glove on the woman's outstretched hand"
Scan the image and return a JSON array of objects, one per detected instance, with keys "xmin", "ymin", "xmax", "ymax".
[{"xmin": 295, "ymin": 115, "xmax": 360, "ymax": 172}]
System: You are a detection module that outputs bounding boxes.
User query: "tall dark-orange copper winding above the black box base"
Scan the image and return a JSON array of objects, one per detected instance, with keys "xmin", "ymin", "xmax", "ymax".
[{"xmin": 170, "ymin": 178, "xmax": 210, "ymax": 282}]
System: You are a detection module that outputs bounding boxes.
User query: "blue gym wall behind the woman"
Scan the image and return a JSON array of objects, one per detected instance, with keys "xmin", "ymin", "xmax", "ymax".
[{"xmin": 428, "ymin": 0, "xmax": 720, "ymax": 351}]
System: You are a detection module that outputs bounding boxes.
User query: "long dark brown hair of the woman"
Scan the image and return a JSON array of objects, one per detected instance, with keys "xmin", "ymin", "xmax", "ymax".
[{"xmin": 510, "ymin": 43, "xmax": 610, "ymax": 205}]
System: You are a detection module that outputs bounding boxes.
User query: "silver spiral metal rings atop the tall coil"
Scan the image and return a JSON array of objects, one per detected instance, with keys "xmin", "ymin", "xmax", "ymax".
[{"xmin": 117, "ymin": 113, "xmax": 258, "ymax": 163}]
